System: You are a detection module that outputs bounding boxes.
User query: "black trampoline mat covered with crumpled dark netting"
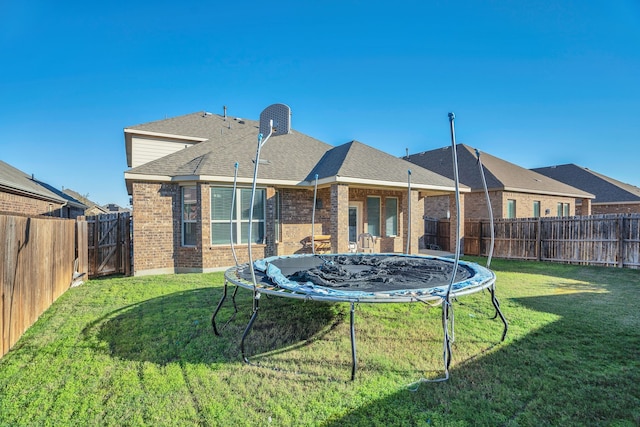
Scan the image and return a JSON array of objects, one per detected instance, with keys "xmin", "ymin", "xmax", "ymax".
[{"xmin": 244, "ymin": 255, "xmax": 475, "ymax": 293}]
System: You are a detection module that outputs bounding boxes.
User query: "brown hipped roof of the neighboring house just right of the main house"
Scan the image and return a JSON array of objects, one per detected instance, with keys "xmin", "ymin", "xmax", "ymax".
[{"xmin": 404, "ymin": 144, "xmax": 594, "ymax": 199}]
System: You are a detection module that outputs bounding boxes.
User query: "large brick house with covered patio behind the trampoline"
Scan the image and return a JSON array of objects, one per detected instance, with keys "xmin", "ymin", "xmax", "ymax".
[{"xmin": 124, "ymin": 104, "xmax": 469, "ymax": 275}]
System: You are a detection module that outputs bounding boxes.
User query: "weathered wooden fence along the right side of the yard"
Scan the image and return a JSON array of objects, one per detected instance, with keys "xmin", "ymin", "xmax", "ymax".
[{"xmin": 464, "ymin": 214, "xmax": 640, "ymax": 268}]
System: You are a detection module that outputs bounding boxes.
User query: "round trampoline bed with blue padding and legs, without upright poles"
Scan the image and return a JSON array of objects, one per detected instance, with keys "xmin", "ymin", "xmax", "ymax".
[{"xmin": 212, "ymin": 253, "xmax": 507, "ymax": 380}]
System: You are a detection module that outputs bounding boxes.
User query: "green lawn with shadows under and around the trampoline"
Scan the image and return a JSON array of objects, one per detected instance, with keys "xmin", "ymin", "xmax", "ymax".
[{"xmin": 0, "ymin": 258, "xmax": 640, "ymax": 426}]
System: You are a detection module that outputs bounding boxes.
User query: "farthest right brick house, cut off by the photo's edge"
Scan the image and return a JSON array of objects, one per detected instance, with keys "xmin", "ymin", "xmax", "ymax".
[{"xmin": 532, "ymin": 164, "xmax": 640, "ymax": 215}]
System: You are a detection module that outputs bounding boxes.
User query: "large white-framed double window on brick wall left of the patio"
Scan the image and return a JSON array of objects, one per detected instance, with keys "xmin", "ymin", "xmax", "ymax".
[{"xmin": 211, "ymin": 187, "xmax": 265, "ymax": 245}]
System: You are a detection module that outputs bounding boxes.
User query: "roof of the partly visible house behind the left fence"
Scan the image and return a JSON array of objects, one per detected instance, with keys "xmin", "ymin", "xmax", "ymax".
[{"xmin": 0, "ymin": 160, "xmax": 84, "ymax": 207}]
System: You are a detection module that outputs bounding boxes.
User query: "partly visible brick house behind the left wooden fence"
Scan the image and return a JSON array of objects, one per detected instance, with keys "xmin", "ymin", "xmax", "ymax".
[{"xmin": 0, "ymin": 160, "xmax": 86, "ymax": 218}]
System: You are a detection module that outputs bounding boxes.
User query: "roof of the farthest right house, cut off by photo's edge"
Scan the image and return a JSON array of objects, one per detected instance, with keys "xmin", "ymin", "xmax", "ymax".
[{"xmin": 532, "ymin": 163, "xmax": 640, "ymax": 204}]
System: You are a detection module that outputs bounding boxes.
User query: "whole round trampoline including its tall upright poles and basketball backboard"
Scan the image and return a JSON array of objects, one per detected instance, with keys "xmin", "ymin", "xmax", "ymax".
[{"xmin": 211, "ymin": 108, "xmax": 508, "ymax": 381}]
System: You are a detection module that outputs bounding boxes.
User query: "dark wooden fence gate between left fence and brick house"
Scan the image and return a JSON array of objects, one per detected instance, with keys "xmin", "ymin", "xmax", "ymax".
[{"xmin": 87, "ymin": 212, "xmax": 131, "ymax": 278}]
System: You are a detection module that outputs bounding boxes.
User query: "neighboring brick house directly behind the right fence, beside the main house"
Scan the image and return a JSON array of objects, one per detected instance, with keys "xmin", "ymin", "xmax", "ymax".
[{"xmin": 404, "ymin": 144, "xmax": 594, "ymax": 219}]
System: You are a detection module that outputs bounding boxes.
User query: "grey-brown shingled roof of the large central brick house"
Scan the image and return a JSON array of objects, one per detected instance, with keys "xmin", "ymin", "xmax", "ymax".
[{"xmin": 125, "ymin": 113, "xmax": 469, "ymax": 193}]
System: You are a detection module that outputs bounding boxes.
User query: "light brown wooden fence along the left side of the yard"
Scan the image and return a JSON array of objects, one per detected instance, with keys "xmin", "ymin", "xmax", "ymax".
[{"xmin": 0, "ymin": 215, "xmax": 86, "ymax": 357}]
